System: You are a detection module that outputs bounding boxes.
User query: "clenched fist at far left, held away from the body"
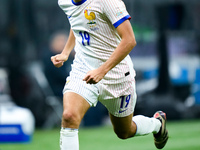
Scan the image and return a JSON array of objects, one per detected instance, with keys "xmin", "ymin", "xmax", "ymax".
[{"xmin": 51, "ymin": 54, "xmax": 68, "ymax": 68}]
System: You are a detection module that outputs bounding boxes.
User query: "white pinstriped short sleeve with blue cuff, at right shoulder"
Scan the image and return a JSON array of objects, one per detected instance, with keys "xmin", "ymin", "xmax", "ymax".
[{"xmin": 102, "ymin": 0, "xmax": 131, "ymax": 28}]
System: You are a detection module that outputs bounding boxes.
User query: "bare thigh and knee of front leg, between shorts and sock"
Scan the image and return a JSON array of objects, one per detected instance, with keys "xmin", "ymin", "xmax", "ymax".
[{"xmin": 62, "ymin": 92, "xmax": 90, "ymax": 128}]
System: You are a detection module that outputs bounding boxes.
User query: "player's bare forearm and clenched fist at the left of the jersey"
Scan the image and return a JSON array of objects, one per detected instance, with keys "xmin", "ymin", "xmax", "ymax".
[{"xmin": 51, "ymin": 29, "xmax": 75, "ymax": 68}]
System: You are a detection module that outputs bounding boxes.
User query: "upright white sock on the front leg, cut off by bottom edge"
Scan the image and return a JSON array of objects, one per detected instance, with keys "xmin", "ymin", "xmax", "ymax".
[{"xmin": 60, "ymin": 128, "xmax": 79, "ymax": 150}]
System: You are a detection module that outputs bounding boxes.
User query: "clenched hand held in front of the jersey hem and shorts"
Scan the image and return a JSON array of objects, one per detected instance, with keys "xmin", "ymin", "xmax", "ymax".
[{"xmin": 83, "ymin": 69, "xmax": 105, "ymax": 84}]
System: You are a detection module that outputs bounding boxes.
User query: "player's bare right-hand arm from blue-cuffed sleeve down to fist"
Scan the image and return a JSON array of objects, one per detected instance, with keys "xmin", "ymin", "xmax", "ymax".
[{"xmin": 83, "ymin": 20, "xmax": 136, "ymax": 84}]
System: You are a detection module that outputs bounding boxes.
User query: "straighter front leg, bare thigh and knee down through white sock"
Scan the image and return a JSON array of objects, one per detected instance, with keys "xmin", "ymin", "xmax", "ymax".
[{"xmin": 60, "ymin": 92, "xmax": 90, "ymax": 150}]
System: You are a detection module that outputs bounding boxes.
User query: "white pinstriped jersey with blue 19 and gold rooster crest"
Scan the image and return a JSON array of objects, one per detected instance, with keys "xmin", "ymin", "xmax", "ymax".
[{"xmin": 58, "ymin": 0, "xmax": 135, "ymax": 97}]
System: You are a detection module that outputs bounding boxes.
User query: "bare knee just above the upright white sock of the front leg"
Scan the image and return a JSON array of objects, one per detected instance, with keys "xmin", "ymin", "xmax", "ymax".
[{"xmin": 62, "ymin": 111, "xmax": 81, "ymax": 127}]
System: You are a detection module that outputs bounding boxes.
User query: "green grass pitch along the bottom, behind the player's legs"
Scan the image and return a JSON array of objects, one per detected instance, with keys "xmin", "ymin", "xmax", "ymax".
[{"xmin": 0, "ymin": 120, "xmax": 200, "ymax": 150}]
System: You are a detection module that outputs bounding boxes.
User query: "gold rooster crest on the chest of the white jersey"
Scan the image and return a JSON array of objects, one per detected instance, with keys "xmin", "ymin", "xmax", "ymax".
[{"xmin": 84, "ymin": 7, "xmax": 99, "ymax": 31}]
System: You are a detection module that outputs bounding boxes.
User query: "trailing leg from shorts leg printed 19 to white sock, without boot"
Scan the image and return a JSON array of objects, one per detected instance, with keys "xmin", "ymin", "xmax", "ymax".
[{"xmin": 101, "ymin": 90, "xmax": 161, "ymax": 139}]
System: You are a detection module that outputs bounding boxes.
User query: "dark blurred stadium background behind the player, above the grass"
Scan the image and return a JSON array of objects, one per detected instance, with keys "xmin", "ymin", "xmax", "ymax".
[{"xmin": 0, "ymin": 0, "xmax": 200, "ymax": 141}]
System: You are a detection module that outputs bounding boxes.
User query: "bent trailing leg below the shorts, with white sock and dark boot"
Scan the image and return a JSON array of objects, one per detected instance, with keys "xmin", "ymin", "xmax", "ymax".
[{"xmin": 110, "ymin": 111, "xmax": 168, "ymax": 149}]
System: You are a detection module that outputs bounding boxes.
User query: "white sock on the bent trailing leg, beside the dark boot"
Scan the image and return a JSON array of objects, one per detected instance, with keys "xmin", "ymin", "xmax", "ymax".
[{"xmin": 132, "ymin": 115, "xmax": 161, "ymax": 136}]
